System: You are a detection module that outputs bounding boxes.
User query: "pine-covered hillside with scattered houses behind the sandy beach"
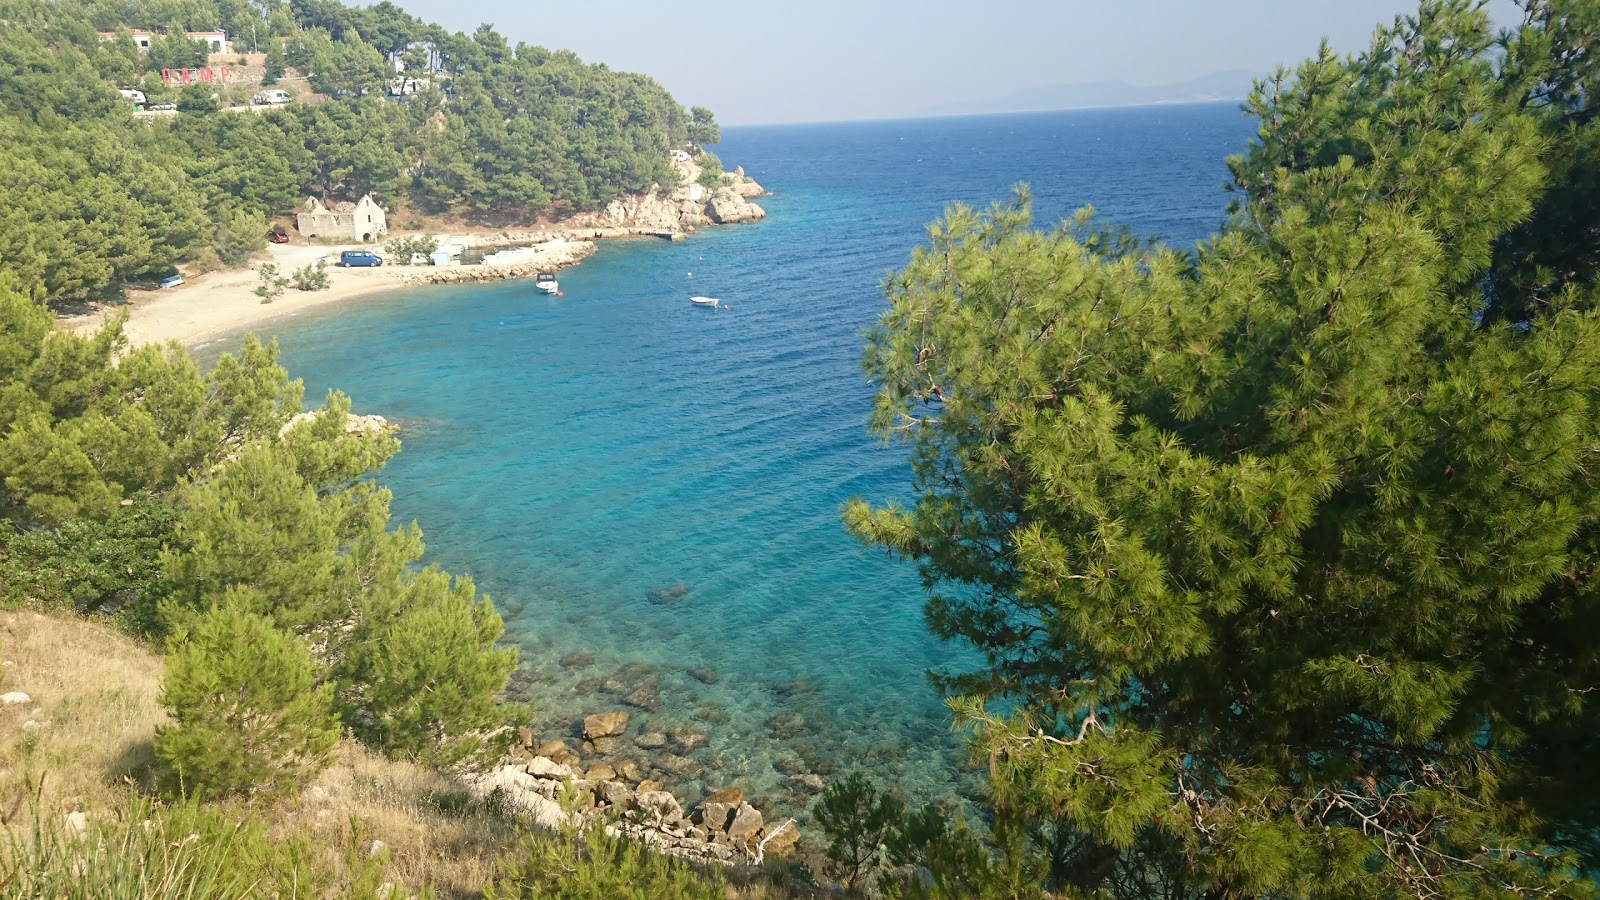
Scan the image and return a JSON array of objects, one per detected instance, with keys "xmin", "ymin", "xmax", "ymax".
[{"xmin": 0, "ymin": 0, "xmax": 709, "ymax": 301}]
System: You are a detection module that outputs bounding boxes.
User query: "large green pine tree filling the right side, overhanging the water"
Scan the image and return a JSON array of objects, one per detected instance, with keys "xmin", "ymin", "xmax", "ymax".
[{"xmin": 845, "ymin": 2, "xmax": 1600, "ymax": 897}]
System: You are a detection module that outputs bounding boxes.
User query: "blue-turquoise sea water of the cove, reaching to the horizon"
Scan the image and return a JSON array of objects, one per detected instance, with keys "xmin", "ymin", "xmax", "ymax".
[{"xmin": 203, "ymin": 104, "xmax": 1251, "ymax": 802}]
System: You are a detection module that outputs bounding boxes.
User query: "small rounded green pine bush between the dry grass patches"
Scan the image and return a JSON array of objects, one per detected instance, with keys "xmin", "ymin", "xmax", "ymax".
[{"xmin": 155, "ymin": 601, "xmax": 339, "ymax": 799}]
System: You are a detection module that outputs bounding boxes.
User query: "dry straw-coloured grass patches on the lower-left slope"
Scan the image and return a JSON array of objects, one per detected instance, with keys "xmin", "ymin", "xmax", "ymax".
[{"xmin": 0, "ymin": 609, "xmax": 795, "ymax": 900}]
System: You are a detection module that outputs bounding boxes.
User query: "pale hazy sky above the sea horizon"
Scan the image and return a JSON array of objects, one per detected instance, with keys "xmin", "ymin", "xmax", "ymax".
[{"xmin": 397, "ymin": 0, "xmax": 1517, "ymax": 125}]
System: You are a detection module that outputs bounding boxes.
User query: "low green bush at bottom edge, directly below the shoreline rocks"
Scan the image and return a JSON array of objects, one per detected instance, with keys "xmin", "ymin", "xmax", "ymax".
[{"xmin": 483, "ymin": 828, "xmax": 728, "ymax": 900}]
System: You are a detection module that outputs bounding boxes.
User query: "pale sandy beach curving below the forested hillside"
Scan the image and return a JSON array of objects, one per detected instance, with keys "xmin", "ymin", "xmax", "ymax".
[{"xmin": 58, "ymin": 235, "xmax": 594, "ymax": 346}]
